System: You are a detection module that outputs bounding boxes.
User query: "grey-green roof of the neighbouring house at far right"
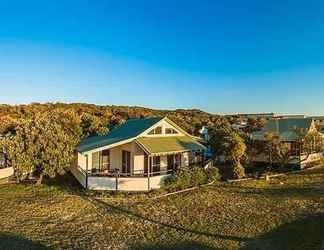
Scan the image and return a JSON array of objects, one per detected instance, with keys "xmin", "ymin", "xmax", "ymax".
[{"xmin": 252, "ymin": 118, "xmax": 313, "ymax": 141}]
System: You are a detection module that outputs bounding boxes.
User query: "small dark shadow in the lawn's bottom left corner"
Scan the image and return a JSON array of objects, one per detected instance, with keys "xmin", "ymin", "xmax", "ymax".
[{"xmin": 0, "ymin": 232, "xmax": 50, "ymax": 250}]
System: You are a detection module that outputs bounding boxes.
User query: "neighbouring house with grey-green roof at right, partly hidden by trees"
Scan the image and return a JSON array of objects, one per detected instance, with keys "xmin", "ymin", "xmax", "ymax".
[{"xmin": 252, "ymin": 118, "xmax": 322, "ymax": 166}]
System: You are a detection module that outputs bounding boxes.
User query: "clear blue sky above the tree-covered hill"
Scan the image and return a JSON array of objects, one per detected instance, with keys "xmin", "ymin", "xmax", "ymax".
[{"xmin": 0, "ymin": 0, "xmax": 324, "ymax": 114}]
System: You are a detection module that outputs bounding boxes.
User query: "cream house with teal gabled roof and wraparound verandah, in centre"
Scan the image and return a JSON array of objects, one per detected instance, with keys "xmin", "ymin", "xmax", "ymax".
[{"xmin": 71, "ymin": 118, "xmax": 206, "ymax": 191}]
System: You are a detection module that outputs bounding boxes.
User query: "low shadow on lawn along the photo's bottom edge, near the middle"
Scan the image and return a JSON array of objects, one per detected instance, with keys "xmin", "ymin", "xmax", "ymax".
[{"xmin": 129, "ymin": 241, "xmax": 217, "ymax": 250}]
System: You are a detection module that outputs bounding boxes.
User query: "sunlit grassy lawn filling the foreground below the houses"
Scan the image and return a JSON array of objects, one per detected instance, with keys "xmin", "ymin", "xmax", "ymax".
[{"xmin": 0, "ymin": 168, "xmax": 324, "ymax": 249}]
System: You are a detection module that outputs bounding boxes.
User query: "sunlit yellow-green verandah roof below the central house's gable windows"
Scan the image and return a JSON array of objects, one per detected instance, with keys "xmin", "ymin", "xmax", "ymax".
[{"xmin": 136, "ymin": 136, "xmax": 206, "ymax": 154}]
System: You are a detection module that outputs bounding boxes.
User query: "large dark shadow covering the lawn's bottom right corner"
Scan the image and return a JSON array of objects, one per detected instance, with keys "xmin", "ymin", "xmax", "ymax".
[{"xmin": 242, "ymin": 213, "xmax": 324, "ymax": 250}]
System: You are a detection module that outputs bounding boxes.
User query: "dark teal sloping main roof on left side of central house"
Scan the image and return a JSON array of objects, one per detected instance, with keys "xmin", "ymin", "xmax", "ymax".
[{"xmin": 77, "ymin": 117, "xmax": 163, "ymax": 153}]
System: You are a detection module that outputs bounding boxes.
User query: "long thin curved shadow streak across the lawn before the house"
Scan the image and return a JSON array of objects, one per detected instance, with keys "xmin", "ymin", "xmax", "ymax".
[{"xmin": 91, "ymin": 199, "xmax": 249, "ymax": 242}]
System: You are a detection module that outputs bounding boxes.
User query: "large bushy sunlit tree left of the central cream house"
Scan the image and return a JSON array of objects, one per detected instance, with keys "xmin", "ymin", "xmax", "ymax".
[{"xmin": 0, "ymin": 111, "xmax": 81, "ymax": 184}]
